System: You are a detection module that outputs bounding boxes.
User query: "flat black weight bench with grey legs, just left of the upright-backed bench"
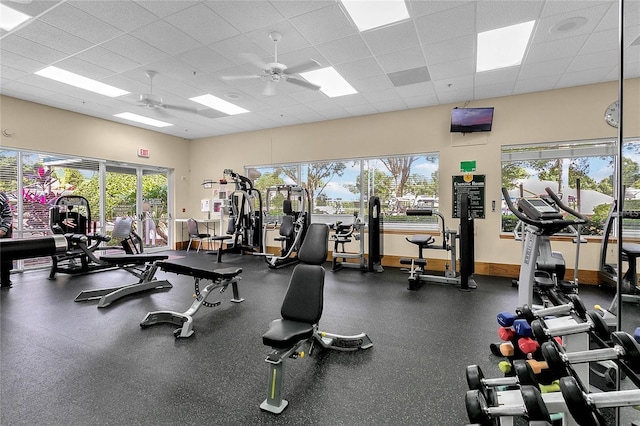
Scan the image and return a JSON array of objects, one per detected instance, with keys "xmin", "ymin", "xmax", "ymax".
[{"xmin": 140, "ymin": 262, "xmax": 244, "ymax": 339}]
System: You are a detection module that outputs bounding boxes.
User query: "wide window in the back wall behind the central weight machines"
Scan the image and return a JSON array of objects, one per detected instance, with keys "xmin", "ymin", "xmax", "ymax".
[{"xmin": 246, "ymin": 153, "xmax": 438, "ymax": 227}]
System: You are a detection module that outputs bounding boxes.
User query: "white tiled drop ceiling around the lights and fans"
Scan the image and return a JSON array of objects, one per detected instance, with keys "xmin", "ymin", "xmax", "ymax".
[{"xmin": 0, "ymin": 0, "xmax": 640, "ymax": 138}]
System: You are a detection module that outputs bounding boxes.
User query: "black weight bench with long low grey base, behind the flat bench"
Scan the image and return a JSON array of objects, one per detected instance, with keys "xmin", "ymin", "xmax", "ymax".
[{"xmin": 74, "ymin": 253, "xmax": 172, "ymax": 308}]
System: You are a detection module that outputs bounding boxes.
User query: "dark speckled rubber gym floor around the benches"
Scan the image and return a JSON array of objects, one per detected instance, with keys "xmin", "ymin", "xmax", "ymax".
[{"xmin": 0, "ymin": 251, "xmax": 637, "ymax": 426}]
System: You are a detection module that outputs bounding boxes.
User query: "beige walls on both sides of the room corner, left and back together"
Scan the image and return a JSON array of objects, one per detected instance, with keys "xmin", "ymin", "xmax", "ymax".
[{"xmin": 0, "ymin": 79, "xmax": 640, "ymax": 280}]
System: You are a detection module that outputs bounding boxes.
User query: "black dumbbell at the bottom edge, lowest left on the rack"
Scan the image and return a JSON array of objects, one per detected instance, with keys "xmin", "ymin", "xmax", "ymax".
[{"xmin": 465, "ymin": 385, "xmax": 551, "ymax": 426}]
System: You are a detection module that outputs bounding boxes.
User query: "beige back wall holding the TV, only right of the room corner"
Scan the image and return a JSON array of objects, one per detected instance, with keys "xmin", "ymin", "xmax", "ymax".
[{"xmin": 190, "ymin": 79, "xmax": 640, "ymax": 280}]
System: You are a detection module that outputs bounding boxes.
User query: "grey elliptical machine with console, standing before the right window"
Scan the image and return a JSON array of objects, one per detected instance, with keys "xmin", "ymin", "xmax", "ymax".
[{"xmin": 502, "ymin": 187, "xmax": 588, "ymax": 307}]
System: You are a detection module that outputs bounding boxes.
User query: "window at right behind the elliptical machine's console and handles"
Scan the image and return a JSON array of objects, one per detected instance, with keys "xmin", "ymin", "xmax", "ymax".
[{"xmin": 502, "ymin": 139, "xmax": 624, "ymax": 235}]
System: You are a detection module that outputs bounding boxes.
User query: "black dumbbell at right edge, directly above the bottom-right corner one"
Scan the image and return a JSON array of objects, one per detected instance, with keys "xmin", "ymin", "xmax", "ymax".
[{"xmin": 542, "ymin": 331, "xmax": 640, "ymax": 378}]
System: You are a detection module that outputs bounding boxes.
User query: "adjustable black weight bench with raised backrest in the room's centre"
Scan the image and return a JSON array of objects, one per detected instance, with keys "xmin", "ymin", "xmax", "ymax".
[{"xmin": 260, "ymin": 223, "xmax": 373, "ymax": 414}]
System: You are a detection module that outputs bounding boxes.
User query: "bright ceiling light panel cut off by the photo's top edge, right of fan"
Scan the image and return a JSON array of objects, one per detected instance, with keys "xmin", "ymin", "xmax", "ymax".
[{"xmin": 342, "ymin": 0, "xmax": 409, "ymax": 31}]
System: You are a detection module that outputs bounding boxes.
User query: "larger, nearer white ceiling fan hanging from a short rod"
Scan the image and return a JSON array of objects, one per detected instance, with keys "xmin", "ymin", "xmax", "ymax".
[{"xmin": 222, "ymin": 31, "xmax": 321, "ymax": 96}]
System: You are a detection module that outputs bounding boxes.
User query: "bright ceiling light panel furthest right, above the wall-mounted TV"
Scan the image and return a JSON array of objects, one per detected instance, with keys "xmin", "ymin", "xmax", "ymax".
[{"xmin": 476, "ymin": 21, "xmax": 536, "ymax": 72}]
